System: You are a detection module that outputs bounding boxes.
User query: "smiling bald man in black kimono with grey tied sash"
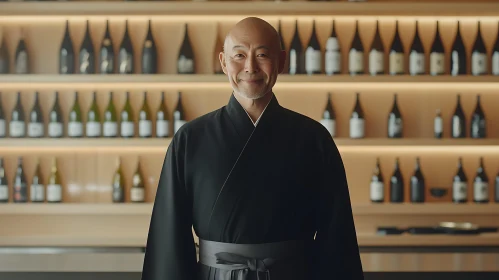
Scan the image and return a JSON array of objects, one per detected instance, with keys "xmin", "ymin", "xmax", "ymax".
[{"xmin": 142, "ymin": 17, "xmax": 363, "ymax": 280}]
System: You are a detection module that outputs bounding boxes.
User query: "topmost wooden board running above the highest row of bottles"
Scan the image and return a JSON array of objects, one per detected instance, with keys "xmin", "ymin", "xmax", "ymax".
[{"xmin": 0, "ymin": 1, "xmax": 499, "ymax": 16}]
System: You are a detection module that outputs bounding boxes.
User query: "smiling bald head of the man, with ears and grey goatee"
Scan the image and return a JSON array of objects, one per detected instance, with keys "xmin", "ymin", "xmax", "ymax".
[{"xmin": 219, "ymin": 18, "xmax": 286, "ymax": 99}]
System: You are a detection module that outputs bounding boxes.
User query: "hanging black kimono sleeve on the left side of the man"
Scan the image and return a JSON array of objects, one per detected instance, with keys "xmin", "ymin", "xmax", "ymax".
[{"xmin": 141, "ymin": 138, "xmax": 197, "ymax": 280}]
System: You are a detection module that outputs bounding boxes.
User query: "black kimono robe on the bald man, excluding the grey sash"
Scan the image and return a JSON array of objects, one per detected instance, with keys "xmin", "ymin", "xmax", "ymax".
[{"xmin": 142, "ymin": 92, "xmax": 363, "ymax": 280}]
